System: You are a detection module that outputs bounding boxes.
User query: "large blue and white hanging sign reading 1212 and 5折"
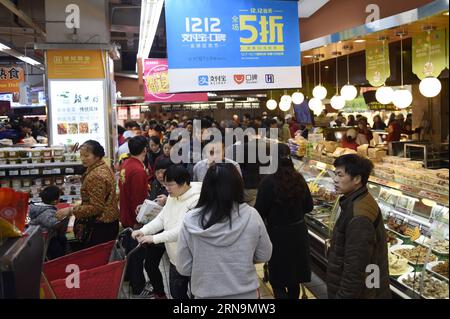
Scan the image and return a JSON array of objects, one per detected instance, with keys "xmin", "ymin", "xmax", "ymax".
[{"xmin": 165, "ymin": 0, "xmax": 301, "ymax": 92}]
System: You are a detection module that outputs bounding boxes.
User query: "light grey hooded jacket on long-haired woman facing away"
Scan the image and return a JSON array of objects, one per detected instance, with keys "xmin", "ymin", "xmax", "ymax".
[{"xmin": 177, "ymin": 203, "xmax": 272, "ymax": 299}]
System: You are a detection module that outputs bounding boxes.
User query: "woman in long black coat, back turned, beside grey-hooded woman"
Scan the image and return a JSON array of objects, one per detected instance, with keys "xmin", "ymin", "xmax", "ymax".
[{"xmin": 255, "ymin": 144, "xmax": 313, "ymax": 299}]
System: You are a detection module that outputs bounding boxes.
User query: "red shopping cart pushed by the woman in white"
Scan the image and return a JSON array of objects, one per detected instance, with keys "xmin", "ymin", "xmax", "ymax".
[{"xmin": 41, "ymin": 228, "xmax": 141, "ymax": 299}]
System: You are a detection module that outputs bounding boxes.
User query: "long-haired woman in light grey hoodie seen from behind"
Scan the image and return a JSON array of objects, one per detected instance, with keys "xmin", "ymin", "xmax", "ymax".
[{"xmin": 177, "ymin": 163, "xmax": 272, "ymax": 299}]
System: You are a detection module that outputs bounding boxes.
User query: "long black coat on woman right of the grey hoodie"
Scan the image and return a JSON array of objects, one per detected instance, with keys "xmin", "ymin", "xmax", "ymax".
[{"xmin": 255, "ymin": 175, "xmax": 313, "ymax": 287}]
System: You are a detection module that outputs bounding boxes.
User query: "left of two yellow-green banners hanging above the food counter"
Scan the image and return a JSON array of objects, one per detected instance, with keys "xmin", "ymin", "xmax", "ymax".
[{"xmin": 366, "ymin": 43, "xmax": 391, "ymax": 87}]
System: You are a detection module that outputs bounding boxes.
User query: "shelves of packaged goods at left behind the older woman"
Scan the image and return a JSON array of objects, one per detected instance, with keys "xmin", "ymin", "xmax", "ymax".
[{"xmin": 0, "ymin": 147, "xmax": 84, "ymax": 202}]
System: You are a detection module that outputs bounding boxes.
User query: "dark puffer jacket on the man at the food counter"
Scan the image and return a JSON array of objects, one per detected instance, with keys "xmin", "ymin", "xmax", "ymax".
[{"xmin": 327, "ymin": 187, "xmax": 391, "ymax": 299}]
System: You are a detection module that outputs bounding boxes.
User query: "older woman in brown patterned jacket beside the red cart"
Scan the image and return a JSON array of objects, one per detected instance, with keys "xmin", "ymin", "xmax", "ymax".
[{"xmin": 57, "ymin": 140, "xmax": 119, "ymax": 248}]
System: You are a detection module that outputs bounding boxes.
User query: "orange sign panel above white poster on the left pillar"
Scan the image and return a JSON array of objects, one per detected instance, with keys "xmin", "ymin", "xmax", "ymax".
[{"xmin": 47, "ymin": 50, "xmax": 105, "ymax": 79}]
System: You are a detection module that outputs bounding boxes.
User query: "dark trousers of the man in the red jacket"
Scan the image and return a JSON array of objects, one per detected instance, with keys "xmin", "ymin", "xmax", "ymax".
[{"xmin": 123, "ymin": 233, "xmax": 145, "ymax": 295}]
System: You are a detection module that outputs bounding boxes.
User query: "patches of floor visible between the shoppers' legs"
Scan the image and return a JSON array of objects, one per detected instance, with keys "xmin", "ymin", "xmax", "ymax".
[{"xmin": 120, "ymin": 254, "xmax": 318, "ymax": 299}]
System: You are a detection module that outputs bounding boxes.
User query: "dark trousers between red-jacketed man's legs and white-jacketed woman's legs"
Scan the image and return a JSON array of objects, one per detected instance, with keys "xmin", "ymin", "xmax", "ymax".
[{"xmin": 144, "ymin": 244, "xmax": 166, "ymax": 295}]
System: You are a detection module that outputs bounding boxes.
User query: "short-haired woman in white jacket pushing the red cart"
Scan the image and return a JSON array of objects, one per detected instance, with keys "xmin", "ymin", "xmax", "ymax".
[{"xmin": 132, "ymin": 165, "xmax": 200, "ymax": 299}]
